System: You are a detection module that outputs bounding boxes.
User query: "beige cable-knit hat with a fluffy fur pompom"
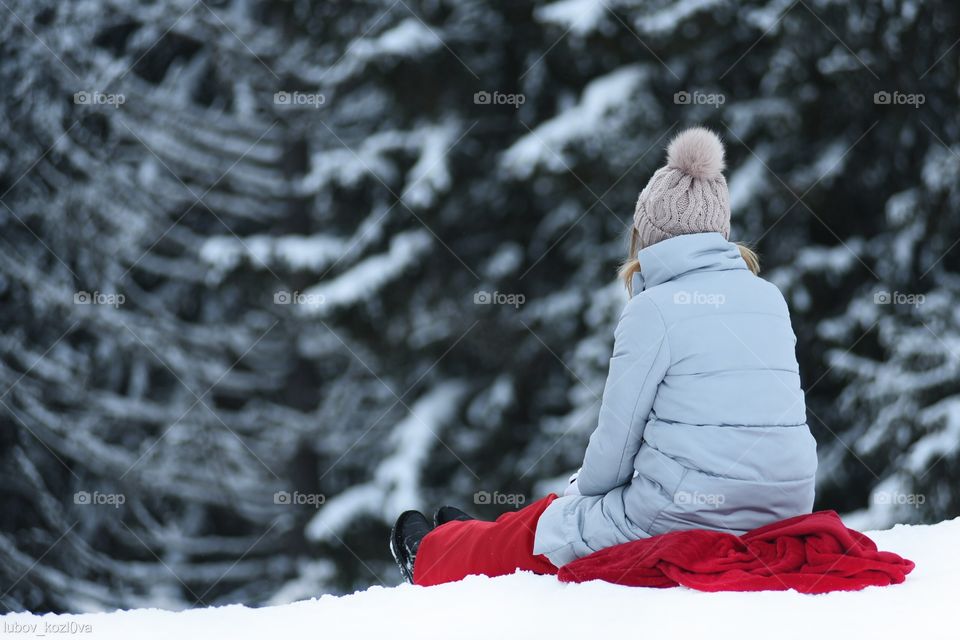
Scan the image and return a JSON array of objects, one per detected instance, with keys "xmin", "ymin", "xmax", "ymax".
[{"xmin": 633, "ymin": 127, "xmax": 730, "ymax": 248}]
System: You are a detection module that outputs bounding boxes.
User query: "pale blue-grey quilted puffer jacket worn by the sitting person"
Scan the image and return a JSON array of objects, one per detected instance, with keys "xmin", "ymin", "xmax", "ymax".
[{"xmin": 534, "ymin": 233, "xmax": 817, "ymax": 567}]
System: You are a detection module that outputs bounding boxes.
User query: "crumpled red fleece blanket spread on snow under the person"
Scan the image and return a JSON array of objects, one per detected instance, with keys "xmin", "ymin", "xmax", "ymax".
[{"xmin": 558, "ymin": 511, "xmax": 914, "ymax": 593}]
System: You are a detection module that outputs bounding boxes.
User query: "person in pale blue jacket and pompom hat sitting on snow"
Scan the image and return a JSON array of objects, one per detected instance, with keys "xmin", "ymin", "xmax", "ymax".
[{"xmin": 390, "ymin": 128, "xmax": 817, "ymax": 585}]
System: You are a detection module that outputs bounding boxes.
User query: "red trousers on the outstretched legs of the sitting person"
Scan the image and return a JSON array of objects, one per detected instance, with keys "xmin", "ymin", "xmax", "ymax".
[{"xmin": 413, "ymin": 493, "xmax": 557, "ymax": 587}]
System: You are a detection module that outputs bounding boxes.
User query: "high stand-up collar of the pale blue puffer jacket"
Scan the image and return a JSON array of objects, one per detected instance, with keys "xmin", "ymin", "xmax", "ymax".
[{"xmin": 633, "ymin": 232, "xmax": 747, "ymax": 295}]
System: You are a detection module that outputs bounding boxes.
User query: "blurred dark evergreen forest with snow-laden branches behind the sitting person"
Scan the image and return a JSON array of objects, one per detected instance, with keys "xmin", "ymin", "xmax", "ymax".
[{"xmin": 0, "ymin": 0, "xmax": 960, "ymax": 611}]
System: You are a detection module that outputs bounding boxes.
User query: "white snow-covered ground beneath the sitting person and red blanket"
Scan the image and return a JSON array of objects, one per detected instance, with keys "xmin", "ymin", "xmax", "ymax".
[{"xmin": 0, "ymin": 518, "xmax": 960, "ymax": 640}]
